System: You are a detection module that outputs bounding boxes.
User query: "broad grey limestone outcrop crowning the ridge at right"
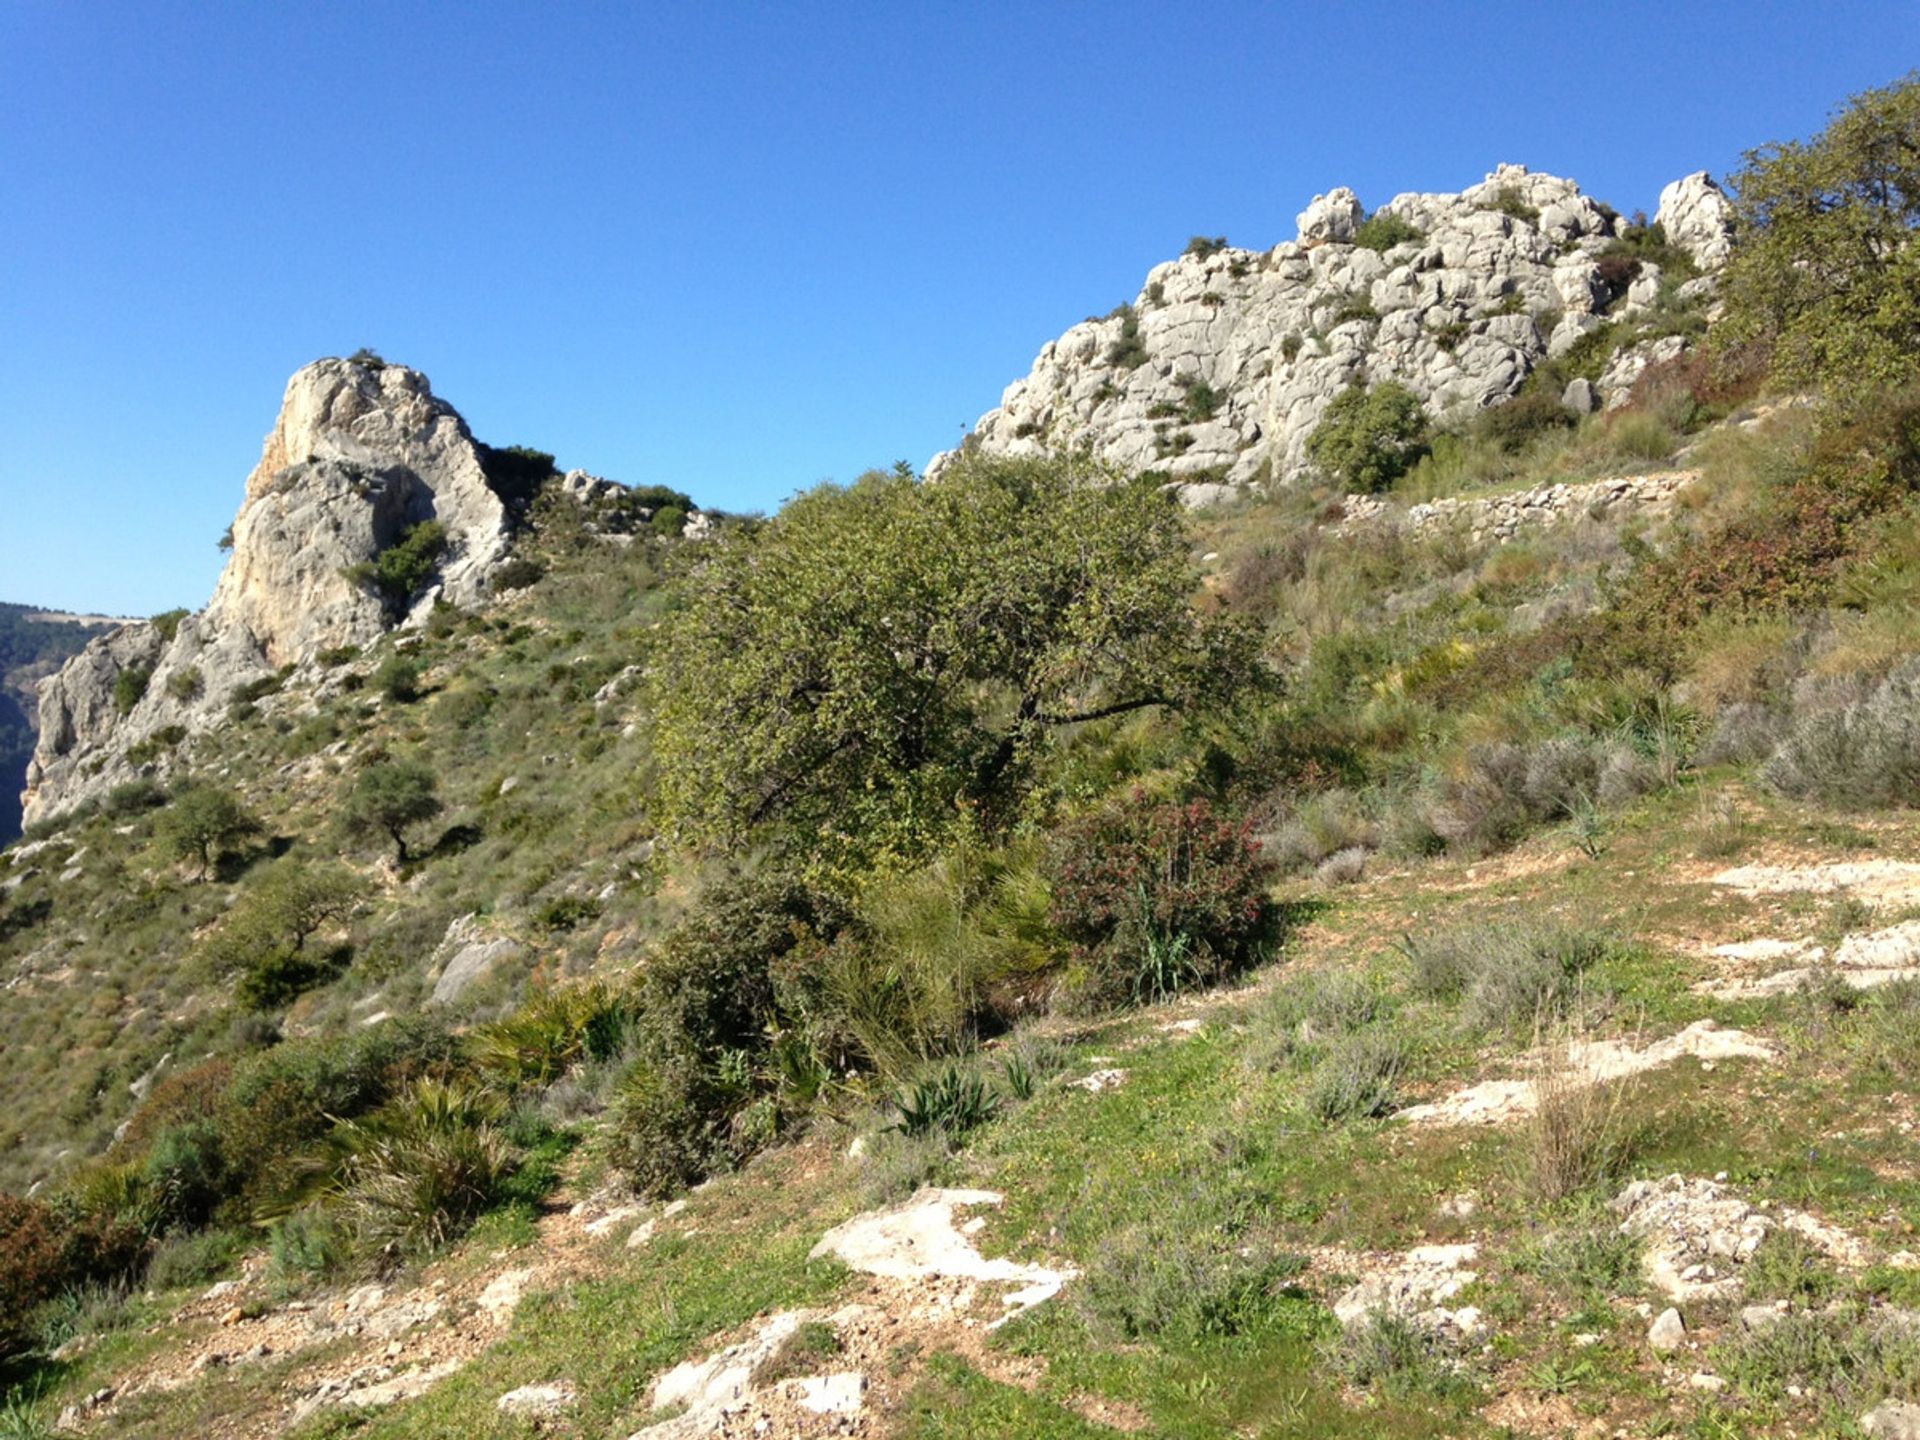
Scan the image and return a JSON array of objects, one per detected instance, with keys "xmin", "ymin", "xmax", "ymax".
[{"xmin": 927, "ymin": 165, "xmax": 1726, "ymax": 497}]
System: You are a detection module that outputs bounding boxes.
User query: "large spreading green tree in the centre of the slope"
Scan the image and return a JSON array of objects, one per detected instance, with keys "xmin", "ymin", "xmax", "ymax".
[{"xmin": 649, "ymin": 455, "xmax": 1258, "ymax": 875}]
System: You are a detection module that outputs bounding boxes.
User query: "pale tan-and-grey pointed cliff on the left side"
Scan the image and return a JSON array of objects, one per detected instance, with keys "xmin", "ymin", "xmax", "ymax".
[{"xmin": 23, "ymin": 359, "xmax": 509, "ymax": 824}]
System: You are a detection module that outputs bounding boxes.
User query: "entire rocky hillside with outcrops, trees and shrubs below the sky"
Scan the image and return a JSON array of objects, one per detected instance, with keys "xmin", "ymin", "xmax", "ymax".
[{"xmin": 0, "ymin": 77, "xmax": 1920, "ymax": 1440}]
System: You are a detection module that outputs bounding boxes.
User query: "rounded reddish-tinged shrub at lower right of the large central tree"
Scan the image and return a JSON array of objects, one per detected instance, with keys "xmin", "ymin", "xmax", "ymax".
[{"xmin": 1052, "ymin": 793, "xmax": 1279, "ymax": 1000}]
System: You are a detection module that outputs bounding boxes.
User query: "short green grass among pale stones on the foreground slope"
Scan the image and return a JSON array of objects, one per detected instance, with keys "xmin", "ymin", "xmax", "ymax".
[{"xmin": 22, "ymin": 776, "xmax": 1920, "ymax": 1436}]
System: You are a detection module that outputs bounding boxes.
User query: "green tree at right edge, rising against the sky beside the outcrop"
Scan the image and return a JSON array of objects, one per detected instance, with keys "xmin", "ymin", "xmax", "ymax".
[{"xmin": 1718, "ymin": 73, "xmax": 1920, "ymax": 394}]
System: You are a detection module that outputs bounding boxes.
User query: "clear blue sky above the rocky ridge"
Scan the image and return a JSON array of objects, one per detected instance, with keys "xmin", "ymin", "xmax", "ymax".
[{"xmin": 0, "ymin": 0, "xmax": 1920, "ymax": 612}]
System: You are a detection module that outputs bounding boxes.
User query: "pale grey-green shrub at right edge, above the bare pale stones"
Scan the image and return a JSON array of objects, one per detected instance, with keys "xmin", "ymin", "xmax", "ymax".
[{"xmin": 1761, "ymin": 662, "xmax": 1920, "ymax": 808}]
